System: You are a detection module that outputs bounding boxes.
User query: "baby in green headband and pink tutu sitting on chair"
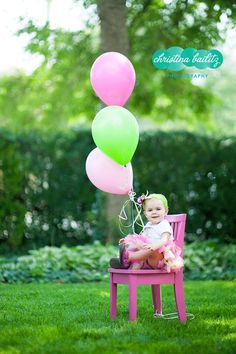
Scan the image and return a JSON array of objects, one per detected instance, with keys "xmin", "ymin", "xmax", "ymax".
[{"xmin": 110, "ymin": 194, "xmax": 183, "ymax": 272}]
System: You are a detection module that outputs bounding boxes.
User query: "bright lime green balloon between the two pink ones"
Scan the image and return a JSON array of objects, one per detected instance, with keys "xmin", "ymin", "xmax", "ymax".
[{"xmin": 92, "ymin": 106, "xmax": 139, "ymax": 165}]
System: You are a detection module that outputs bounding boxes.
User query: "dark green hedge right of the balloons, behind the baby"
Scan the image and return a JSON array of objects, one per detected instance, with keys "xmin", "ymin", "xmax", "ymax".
[{"xmin": 132, "ymin": 131, "xmax": 236, "ymax": 243}]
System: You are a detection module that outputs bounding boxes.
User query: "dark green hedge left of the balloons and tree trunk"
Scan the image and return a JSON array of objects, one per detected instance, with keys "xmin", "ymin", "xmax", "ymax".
[{"xmin": 0, "ymin": 131, "xmax": 105, "ymax": 250}]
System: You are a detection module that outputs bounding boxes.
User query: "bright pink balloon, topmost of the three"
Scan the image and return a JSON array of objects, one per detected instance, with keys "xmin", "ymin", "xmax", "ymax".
[{"xmin": 90, "ymin": 52, "xmax": 135, "ymax": 106}]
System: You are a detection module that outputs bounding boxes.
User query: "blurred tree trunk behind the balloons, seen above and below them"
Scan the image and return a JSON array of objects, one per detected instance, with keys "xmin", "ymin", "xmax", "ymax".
[{"xmin": 98, "ymin": 0, "xmax": 129, "ymax": 241}]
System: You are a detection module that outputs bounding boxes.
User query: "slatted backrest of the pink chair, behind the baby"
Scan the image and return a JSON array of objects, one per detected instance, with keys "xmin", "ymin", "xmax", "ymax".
[{"xmin": 165, "ymin": 214, "xmax": 187, "ymax": 253}]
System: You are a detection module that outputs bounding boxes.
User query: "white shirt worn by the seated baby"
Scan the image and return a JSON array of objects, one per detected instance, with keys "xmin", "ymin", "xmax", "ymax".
[{"xmin": 141, "ymin": 219, "xmax": 174, "ymax": 243}]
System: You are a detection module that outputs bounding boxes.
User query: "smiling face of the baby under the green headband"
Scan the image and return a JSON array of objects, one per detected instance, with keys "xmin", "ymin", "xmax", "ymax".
[{"xmin": 144, "ymin": 198, "xmax": 167, "ymax": 224}]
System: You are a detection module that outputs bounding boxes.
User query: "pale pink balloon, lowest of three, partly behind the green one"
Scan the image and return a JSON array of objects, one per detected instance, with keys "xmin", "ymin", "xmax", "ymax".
[{"xmin": 86, "ymin": 148, "xmax": 133, "ymax": 194}]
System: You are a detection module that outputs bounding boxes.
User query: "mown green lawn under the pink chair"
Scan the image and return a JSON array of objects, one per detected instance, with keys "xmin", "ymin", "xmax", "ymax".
[{"xmin": 0, "ymin": 281, "xmax": 236, "ymax": 354}]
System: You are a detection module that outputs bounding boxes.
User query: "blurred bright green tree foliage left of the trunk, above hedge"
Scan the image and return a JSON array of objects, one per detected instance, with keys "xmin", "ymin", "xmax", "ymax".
[{"xmin": 0, "ymin": 21, "xmax": 100, "ymax": 132}]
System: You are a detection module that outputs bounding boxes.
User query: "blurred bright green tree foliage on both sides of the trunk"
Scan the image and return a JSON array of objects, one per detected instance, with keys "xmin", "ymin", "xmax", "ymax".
[{"xmin": 0, "ymin": 0, "xmax": 236, "ymax": 131}]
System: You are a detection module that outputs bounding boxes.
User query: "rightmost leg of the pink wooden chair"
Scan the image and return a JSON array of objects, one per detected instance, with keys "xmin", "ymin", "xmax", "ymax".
[{"xmin": 174, "ymin": 271, "xmax": 187, "ymax": 322}]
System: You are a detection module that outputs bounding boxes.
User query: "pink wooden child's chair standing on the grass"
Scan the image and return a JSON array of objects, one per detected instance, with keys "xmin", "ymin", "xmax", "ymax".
[{"xmin": 108, "ymin": 214, "xmax": 186, "ymax": 322}]
